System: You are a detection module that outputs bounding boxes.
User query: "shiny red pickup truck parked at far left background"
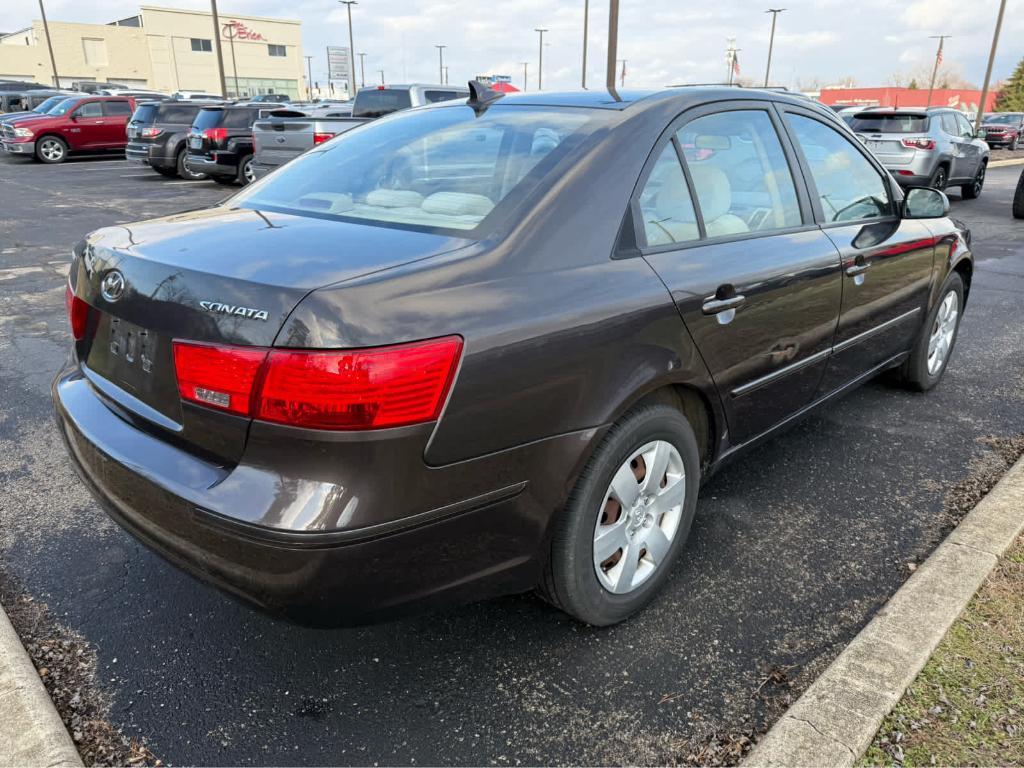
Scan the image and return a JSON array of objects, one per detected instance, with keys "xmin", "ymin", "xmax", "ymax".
[{"xmin": 0, "ymin": 96, "xmax": 135, "ymax": 163}]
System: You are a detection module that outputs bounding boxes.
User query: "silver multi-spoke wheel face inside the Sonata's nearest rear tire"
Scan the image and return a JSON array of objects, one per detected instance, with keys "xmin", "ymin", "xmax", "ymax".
[{"xmin": 593, "ymin": 440, "xmax": 686, "ymax": 595}]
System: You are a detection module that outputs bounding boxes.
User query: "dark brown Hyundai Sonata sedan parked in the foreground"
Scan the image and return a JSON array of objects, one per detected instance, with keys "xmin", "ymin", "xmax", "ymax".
[{"xmin": 53, "ymin": 85, "xmax": 973, "ymax": 625}]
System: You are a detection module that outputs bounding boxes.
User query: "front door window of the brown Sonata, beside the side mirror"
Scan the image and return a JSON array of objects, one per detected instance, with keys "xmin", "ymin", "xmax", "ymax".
[{"xmin": 785, "ymin": 114, "xmax": 892, "ymax": 222}]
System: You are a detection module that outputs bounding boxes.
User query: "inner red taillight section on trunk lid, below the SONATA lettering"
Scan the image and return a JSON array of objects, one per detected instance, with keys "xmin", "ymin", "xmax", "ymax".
[{"xmin": 174, "ymin": 341, "xmax": 266, "ymax": 416}]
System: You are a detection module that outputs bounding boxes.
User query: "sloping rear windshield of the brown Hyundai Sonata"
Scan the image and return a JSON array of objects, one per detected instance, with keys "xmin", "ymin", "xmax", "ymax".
[{"xmin": 232, "ymin": 105, "xmax": 597, "ymax": 230}]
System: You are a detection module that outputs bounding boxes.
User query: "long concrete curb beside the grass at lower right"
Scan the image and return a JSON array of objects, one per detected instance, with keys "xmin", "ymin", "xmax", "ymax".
[{"xmin": 743, "ymin": 454, "xmax": 1024, "ymax": 768}]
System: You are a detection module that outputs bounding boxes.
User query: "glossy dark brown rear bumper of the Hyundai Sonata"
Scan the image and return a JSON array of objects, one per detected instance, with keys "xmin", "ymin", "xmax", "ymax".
[{"xmin": 52, "ymin": 364, "xmax": 592, "ymax": 626}]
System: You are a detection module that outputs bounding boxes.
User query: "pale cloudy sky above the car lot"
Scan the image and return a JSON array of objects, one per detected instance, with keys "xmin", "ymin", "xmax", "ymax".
[{"xmin": 8, "ymin": 0, "xmax": 1024, "ymax": 90}]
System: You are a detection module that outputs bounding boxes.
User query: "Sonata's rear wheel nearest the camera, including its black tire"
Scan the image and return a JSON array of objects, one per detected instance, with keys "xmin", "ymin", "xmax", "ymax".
[{"xmin": 541, "ymin": 404, "xmax": 700, "ymax": 627}]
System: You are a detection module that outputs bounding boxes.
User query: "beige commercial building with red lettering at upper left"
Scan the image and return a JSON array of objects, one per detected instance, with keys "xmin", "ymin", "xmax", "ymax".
[{"xmin": 0, "ymin": 5, "xmax": 306, "ymax": 98}]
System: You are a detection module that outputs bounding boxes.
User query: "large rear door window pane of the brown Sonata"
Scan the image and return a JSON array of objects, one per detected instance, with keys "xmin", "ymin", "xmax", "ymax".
[{"xmin": 676, "ymin": 110, "xmax": 803, "ymax": 238}]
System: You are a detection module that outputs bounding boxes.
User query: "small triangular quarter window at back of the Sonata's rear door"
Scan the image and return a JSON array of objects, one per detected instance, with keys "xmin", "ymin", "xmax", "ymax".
[{"xmin": 640, "ymin": 141, "xmax": 700, "ymax": 247}]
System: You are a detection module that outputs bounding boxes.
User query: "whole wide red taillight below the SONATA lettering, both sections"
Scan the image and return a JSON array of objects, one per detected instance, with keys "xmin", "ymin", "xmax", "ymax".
[{"xmin": 174, "ymin": 336, "xmax": 462, "ymax": 430}]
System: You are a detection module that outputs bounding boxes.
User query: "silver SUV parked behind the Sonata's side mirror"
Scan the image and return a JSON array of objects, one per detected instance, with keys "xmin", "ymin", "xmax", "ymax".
[{"xmin": 850, "ymin": 109, "xmax": 988, "ymax": 200}]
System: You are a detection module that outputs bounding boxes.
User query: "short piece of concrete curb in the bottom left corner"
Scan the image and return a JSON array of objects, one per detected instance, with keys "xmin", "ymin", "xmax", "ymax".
[{"xmin": 0, "ymin": 608, "xmax": 82, "ymax": 768}]
